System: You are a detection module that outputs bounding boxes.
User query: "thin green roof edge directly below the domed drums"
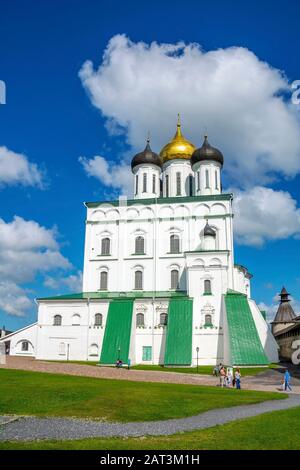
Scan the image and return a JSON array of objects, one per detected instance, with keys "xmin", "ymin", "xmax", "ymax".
[{"xmin": 84, "ymin": 193, "xmax": 233, "ymax": 207}]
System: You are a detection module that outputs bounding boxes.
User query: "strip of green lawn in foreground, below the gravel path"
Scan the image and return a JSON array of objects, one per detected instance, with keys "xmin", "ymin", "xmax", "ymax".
[{"xmin": 0, "ymin": 408, "xmax": 300, "ymax": 450}]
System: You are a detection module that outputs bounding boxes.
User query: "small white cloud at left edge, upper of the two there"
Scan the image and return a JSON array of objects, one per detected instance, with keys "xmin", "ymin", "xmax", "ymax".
[{"xmin": 0, "ymin": 146, "xmax": 44, "ymax": 188}]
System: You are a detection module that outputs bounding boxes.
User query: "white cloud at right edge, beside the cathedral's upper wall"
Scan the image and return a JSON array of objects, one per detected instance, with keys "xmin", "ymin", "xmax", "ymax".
[{"xmin": 234, "ymin": 186, "xmax": 300, "ymax": 246}]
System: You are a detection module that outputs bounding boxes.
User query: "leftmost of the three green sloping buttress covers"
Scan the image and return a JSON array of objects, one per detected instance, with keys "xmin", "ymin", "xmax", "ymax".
[{"xmin": 100, "ymin": 300, "xmax": 133, "ymax": 364}]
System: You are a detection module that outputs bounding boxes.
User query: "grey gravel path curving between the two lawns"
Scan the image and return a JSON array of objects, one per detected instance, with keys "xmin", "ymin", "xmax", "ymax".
[{"xmin": 0, "ymin": 395, "xmax": 300, "ymax": 441}]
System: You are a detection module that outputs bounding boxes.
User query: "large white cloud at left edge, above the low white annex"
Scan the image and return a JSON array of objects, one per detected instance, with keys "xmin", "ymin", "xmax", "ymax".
[{"xmin": 0, "ymin": 216, "xmax": 72, "ymax": 316}]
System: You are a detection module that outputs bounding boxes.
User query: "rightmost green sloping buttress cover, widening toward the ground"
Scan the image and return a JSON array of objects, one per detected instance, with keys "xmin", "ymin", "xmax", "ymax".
[{"xmin": 225, "ymin": 291, "xmax": 269, "ymax": 366}]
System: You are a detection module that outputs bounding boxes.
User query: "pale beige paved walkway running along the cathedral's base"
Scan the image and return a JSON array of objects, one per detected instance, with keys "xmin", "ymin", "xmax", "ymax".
[{"xmin": 0, "ymin": 356, "xmax": 300, "ymax": 395}]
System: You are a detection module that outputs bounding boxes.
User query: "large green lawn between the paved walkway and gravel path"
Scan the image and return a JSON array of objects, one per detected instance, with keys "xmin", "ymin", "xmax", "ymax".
[{"xmin": 0, "ymin": 369, "xmax": 285, "ymax": 422}]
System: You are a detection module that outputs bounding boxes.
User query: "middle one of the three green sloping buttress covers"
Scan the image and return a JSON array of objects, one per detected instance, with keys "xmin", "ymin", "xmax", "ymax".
[{"xmin": 164, "ymin": 299, "xmax": 193, "ymax": 366}]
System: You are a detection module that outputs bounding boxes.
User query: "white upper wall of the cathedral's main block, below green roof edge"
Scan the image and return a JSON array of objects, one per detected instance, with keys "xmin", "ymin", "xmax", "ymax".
[{"xmin": 83, "ymin": 200, "xmax": 234, "ymax": 292}]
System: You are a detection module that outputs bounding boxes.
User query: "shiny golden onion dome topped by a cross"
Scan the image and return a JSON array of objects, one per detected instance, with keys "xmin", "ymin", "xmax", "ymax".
[{"xmin": 159, "ymin": 114, "xmax": 196, "ymax": 162}]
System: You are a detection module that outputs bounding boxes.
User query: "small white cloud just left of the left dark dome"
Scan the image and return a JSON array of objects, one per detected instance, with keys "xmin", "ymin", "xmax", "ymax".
[{"xmin": 79, "ymin": 155, "xmax": 132, "ymax": 194}]
